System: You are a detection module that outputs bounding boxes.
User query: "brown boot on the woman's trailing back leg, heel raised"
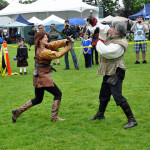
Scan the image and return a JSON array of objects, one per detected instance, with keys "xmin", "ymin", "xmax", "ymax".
[{"xmin": 12, "ymin": 101, "xmax": 33, "ymax": 123}]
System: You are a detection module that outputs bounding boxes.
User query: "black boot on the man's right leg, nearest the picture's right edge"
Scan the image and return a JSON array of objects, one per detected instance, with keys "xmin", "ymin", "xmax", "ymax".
[{"xmin": 120, "ymin": 102, "xmax": 137, "ymax": 129}]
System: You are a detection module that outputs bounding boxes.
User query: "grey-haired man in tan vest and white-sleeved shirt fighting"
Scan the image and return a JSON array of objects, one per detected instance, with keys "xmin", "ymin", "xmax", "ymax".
[{"xmin": 89, "ymin": 18, "xmax": 137, "ymax": 129}]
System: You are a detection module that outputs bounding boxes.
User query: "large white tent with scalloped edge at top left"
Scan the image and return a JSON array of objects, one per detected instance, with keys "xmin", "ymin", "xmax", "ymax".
[{"xmin": 0, "ymin": 0, "xmax": 99, "ymax": 20}]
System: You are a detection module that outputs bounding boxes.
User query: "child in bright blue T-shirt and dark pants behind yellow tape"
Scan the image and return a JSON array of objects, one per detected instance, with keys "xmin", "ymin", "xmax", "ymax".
[{"xmin": 81, "ymin": 34, "xmax": 92, "ymax": 68}]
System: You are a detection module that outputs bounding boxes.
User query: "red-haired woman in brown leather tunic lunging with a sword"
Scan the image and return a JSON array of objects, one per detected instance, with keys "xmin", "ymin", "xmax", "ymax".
[{"xmin": 12, "ymin": 32, "xmax": 74, "ymax": 123}]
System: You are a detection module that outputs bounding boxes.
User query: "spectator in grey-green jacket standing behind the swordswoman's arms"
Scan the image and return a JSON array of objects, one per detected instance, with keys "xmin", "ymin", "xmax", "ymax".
[{"xmin": 48, "ymin": 23, "xmax": 60, "ymax": 65}]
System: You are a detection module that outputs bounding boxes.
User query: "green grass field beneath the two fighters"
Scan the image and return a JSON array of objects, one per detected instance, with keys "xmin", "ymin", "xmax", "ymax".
[{"xmin": 0, "ymin": 41, "xmax": 150, "ymax": 150}]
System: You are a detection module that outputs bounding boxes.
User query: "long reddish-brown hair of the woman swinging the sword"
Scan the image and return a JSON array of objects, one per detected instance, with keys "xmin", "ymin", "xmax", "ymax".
[{"xmin": 34, "ymin": 32, "xmax": 48, "ymax": 54}]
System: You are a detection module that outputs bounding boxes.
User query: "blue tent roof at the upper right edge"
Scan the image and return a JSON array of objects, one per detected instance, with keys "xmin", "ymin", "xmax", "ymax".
[{"xmin": 129, "ymin": 3, "xmax": 150, "ymax": 19}]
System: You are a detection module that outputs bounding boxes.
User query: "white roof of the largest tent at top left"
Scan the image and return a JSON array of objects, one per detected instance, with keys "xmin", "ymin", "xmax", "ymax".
[{"xmin": 0, "ymin": 0, "xmax": 99, "ymax": 16}]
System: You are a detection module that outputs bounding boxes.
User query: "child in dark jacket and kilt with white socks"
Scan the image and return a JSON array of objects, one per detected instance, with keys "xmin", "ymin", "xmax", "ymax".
[{"xmin": 16, "ymin": 38, "xmax": 28, "ymax": 75}]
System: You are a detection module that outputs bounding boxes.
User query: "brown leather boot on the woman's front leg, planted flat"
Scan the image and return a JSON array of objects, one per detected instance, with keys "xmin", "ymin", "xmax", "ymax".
[{"xmin": 51, "ymin": 100, "xmax": 66, "ymax": 121}]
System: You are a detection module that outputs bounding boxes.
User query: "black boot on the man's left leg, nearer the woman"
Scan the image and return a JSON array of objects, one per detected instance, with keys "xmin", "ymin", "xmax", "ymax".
[{"xmin": 89, "ymin": 102, "xmax": 108, "ymax": 120}]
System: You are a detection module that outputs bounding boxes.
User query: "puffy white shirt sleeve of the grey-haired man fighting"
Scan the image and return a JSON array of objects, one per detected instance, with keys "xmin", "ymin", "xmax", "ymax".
[{"xmin": 96, "ymin": 41, "xmax": 124, "ymax": 59}]
